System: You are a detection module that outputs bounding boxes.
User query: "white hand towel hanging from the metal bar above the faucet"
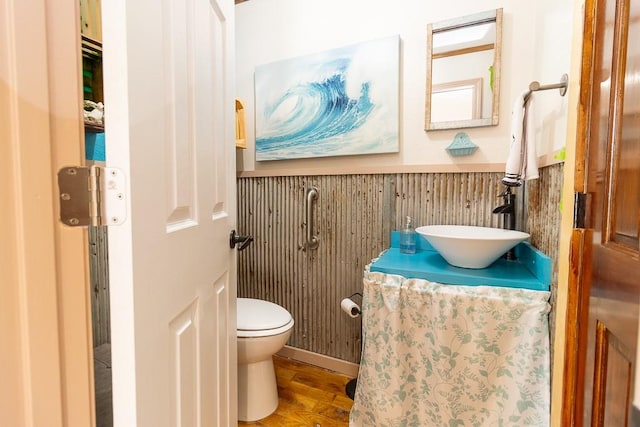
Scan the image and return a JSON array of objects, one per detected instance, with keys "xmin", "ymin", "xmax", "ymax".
[{"xmin": 502, "ymin": 90, "xmax": 539, "ymax": 187}]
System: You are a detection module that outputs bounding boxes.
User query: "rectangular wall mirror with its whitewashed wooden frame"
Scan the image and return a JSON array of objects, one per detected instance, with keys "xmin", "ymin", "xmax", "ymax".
[{"xmin": 425, "ymin": 9, "xmax": 502, "ymax": 131}]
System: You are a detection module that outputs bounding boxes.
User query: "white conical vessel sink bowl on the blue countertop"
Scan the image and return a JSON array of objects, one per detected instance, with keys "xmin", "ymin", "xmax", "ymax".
[{"xmin": 416, "ymin": 225, "xmax": 529, "ymax": 268}]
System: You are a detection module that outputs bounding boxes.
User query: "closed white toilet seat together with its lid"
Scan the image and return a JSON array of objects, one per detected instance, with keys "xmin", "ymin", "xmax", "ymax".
[{"xmin": 237, "ymin": 298, "xmax": 294, "ymax": 338}]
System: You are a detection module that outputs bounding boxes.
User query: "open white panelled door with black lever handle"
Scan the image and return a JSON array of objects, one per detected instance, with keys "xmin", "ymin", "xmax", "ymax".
[{"xmin": 102, "ymin": 0, "xmax": 237, "ymax": 427}]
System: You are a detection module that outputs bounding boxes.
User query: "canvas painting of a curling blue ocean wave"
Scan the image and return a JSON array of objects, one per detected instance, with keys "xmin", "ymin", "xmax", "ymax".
[{"xmin": 255, "ymin": 36, "xmax": 400, "ymax": 161}]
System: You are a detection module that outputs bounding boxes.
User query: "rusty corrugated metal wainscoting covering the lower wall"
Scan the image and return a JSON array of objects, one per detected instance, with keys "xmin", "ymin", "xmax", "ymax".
[{"xmin": 238, "ymin": 171, "xmax": 562, "ymax": 363}]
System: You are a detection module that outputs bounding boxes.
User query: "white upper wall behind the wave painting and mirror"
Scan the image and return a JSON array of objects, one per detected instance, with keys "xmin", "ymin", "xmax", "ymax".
[{"xmin": 236, "ymin": 0, "xmax": 577, "ymax": 174}]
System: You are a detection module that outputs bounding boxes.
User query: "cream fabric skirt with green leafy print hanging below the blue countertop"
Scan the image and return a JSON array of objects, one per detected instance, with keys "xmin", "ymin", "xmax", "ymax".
[{"xmin": 350, "ymin": 268, "xmax": 550, "ymax": 427}]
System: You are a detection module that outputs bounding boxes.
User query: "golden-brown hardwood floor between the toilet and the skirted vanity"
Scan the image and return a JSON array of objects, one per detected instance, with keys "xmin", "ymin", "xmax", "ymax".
[{"xmin": 238, "ymin": 356, "xmax": 353, "ymax": 427}]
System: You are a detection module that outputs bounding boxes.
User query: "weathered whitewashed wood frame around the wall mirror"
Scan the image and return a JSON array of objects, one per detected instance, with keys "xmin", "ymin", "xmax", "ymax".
[{"xmin": 425, "ymin": 8, "xmax": 502, "ymax": 131}]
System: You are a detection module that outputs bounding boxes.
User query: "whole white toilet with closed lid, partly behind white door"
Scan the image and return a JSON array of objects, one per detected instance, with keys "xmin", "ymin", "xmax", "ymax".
[{"xmin": 238, "ymin": 298, "xmax": 293, "ymax": 421}]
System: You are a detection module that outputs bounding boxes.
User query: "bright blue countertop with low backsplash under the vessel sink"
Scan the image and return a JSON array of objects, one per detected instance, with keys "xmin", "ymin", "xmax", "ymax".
[{"xmin": 370, "ymin": 231, "xmax": 551, "ymax": 291}]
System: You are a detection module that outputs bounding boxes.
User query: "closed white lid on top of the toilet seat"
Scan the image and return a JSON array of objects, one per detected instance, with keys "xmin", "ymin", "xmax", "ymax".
[{"xmin": 238, "ymin": 298, "xmax": 292, "ymax": 331}]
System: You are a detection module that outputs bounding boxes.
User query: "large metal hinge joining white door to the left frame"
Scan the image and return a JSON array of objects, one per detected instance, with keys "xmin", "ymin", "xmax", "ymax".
[{"xmin": 58, "ymin": 165, "xmax": 127, "ymax": 227}]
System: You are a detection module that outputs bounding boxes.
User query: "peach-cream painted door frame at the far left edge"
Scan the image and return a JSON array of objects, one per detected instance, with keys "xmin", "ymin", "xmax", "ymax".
[{"xmin": 0, "ymin": 0, "xmax": 95, "ymax": 426}]
